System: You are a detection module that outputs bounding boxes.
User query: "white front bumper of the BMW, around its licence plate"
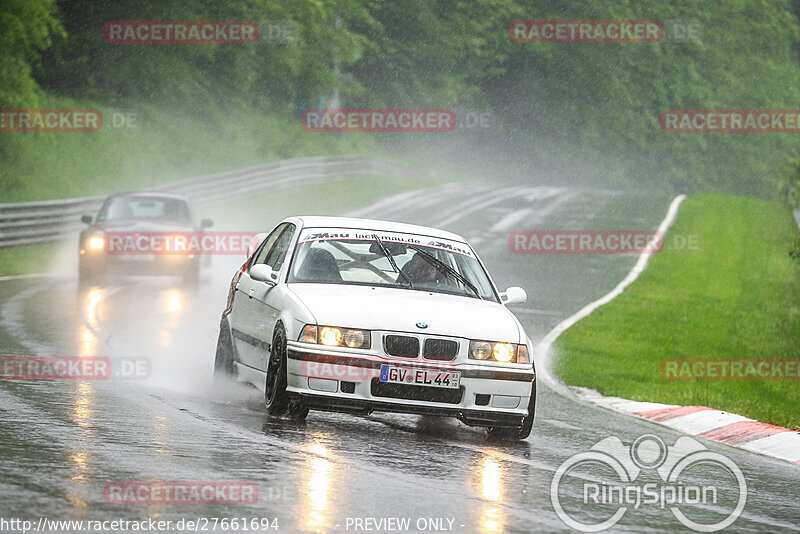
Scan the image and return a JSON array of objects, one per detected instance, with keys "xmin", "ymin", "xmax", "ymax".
[{"xmin": 287, "ymin": 341, "xmax": 535, "ymax": 426}]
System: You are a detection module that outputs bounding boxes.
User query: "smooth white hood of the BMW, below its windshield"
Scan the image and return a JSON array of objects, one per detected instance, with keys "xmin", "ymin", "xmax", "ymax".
[{"xmin": 289, "ymin": 283, "xmax": 526, "ymax": 343}]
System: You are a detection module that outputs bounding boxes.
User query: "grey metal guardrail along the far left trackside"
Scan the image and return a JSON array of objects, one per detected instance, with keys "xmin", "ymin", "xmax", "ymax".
[{"xmin": 0, "ymin": 156, "xmax": 414, "ymax": 248}]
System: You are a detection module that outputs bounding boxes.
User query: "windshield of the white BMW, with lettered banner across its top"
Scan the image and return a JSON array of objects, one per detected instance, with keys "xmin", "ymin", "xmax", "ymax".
[{"xmin": 289, "ymin": 228, "xmax": 497, "ymax": 302}]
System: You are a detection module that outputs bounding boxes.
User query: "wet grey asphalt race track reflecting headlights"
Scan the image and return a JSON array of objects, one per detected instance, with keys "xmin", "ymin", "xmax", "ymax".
[{"xmin": 0, "ymin": 185, "xmax": 800, "ymax": 533}]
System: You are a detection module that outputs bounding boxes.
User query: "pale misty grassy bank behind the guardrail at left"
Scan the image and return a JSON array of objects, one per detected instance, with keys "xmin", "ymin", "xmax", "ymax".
[{"xmin": 0, "ymin": 94, "xmax": 376, "ymax": 202}]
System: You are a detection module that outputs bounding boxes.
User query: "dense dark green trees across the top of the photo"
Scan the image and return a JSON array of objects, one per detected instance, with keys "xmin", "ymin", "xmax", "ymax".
[{"xmin": 0, "ymin": 0, "xmax": 800, "ymax": 197}]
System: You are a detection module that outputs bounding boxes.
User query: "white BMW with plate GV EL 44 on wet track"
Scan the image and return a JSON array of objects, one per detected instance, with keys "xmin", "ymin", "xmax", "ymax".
[{"xmin": 215, "ymin": 217, "xmax": 536, "ymax": 439}]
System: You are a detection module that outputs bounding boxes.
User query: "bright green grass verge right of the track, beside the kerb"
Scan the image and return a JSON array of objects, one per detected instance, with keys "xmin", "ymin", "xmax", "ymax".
[{"xmin": 554, "ymin": 195, "xmax": 800, "ymax": 429}]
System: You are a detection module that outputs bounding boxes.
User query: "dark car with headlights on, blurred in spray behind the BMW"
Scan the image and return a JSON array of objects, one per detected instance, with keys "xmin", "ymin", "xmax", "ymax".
[{"xmin": 78, "ymin": 192, "xmax": 213, "ymax": 284}]
